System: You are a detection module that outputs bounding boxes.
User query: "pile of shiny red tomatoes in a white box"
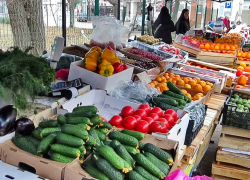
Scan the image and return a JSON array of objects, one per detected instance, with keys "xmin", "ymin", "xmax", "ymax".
[{"xmin": 109, "ymin": 104, "xmax": 179, "ymax": 133}]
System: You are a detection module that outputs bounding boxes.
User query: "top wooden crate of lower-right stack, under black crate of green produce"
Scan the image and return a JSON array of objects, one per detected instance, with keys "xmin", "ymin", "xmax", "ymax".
[{"xmin": 218, "ymin": 126, "xmax": 250, "ymax": 152}]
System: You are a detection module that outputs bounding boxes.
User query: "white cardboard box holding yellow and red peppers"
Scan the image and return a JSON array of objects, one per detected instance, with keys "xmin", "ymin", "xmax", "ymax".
[{"xmin": 68, "ymin": 61, "xmax": 134, "ymax": 93}]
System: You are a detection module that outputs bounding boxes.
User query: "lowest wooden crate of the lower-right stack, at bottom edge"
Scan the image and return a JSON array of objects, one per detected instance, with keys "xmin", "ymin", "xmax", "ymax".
[{"xmin": 212, "ymin": 163, "xmax": 250, "ymax": 180}]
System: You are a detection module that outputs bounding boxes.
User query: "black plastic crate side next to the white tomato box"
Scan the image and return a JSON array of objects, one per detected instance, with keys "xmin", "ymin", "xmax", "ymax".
[{"xmin": 184, "ymin": 105, "xmax": 207, "ymax": 146}]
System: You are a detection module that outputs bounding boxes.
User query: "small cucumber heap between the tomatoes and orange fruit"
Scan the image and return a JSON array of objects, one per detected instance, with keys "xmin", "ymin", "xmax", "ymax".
[{"xmin": 151, "ymin": 81, "xmax": 192, "ymax": 111}]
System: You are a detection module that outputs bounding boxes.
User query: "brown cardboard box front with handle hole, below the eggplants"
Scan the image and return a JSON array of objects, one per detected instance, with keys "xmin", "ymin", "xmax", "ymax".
[{"xmin": 0, "ymin": 140, "xmax": 70, "ymax": 180}]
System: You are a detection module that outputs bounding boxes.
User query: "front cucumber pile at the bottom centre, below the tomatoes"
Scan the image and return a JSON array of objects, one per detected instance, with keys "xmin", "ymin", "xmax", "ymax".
[{"xmin": 82, "ymin": 130, "xmax": 173, "ymax": 180}]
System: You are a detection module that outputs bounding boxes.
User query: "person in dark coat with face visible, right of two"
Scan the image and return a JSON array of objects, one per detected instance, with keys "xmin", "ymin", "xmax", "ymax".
[{"xmin": 175, "ymin": 9, "xmax": 190, "ymax": 34}]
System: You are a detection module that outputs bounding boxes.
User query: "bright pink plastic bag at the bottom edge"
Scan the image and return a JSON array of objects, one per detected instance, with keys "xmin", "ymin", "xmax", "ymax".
[{"xmin": 165, "ymin": 170, "xmax": 213, "ymax": 180}]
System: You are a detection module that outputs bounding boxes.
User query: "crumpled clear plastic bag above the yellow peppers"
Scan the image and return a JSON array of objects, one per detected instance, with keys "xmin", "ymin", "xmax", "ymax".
[{"xmin": 90, "ymin": 16, "xmax": 128, "ymax": 49}]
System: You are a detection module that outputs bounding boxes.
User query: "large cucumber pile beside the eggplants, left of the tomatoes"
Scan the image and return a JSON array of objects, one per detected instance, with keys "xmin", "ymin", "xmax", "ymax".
[{"xmin": 12, "ymin": 106, "xmax": 112, "ymax": 163}]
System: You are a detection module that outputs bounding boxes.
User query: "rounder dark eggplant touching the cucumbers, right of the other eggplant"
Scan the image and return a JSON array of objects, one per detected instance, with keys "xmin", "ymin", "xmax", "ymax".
[{"xmin": 14, "ymin": 118, "xmax": 35, "ymax": 136}]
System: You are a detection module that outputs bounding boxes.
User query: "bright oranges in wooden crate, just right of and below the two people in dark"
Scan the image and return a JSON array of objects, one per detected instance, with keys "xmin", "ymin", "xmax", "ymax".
[{"xmin": 200, "ymin": 43, "xmax": 239, "ymax": 54}]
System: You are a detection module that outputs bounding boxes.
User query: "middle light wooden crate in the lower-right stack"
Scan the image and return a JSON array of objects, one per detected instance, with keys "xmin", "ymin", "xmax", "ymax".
[{"xmin": 216, "ymin": 150, "xmax": 250, "ymax": 168}]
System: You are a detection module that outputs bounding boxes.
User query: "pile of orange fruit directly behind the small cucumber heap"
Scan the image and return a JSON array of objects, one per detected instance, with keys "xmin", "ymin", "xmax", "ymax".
[{"xmin": 149, "ymin": 73, "xmax": 213, "ymax": 96}]
